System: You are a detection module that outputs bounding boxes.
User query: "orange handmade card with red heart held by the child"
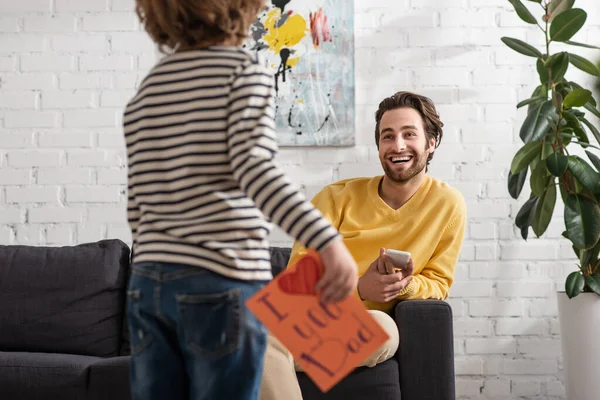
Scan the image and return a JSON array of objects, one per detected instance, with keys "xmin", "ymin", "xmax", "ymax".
[{"xmin": 246, "ymin": 250, "xmax": 389, "ymax": 392}]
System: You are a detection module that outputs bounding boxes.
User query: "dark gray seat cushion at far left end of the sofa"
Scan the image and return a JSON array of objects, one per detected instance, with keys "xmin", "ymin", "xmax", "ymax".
[{"xmin": 0, "ymin": 352, "xmax": 100, "ymax": 400}]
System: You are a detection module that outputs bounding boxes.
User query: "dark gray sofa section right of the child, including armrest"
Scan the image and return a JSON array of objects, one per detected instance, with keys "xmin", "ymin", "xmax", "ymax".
[{"xmin": 271, "ymin": 247, "xmax": 456, "ymax": 400}]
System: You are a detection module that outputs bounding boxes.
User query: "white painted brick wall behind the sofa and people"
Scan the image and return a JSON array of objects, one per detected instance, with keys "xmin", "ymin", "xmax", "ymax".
[{"xmin": 0, "ymin": 0, "xmax": 600, "ymax": 400}]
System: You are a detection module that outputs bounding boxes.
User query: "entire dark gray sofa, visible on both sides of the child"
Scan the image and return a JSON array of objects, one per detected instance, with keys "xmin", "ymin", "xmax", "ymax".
[{"xmin": 0, "ymin": 240, "xmax": 455, "ymax": 400}]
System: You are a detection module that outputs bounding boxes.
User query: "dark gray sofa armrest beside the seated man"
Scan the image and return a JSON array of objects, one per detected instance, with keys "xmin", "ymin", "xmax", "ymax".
[{"xmin": 392, "ymin": 300, "xmax": 456, "ymax": 400}]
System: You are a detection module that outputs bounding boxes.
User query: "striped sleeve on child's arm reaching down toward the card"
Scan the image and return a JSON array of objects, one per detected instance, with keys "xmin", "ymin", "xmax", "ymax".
[{"xmin": 227, "ymin": 62, "xmax": 338, "ymax": 250}]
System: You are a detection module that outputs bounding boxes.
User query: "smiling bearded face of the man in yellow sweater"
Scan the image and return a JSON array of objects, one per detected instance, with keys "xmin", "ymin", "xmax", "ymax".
[{"xmin": 379, "ymin": 107, "xmax": 435, "ymax": 183}]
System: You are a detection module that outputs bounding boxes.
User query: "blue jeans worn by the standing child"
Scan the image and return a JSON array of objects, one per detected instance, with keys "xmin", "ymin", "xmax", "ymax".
[{"xmin": 127, "ymin": 263, "xmax": 267, "ymax": 400}]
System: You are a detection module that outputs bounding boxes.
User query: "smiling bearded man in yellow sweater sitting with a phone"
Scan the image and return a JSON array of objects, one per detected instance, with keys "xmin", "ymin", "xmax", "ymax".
[{"xmin": 261, "ymin": 92, "xmax": 466, "ymax": 400}]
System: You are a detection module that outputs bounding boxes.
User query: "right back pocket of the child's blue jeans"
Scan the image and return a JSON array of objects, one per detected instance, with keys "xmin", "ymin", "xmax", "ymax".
[{"xmin": 177, "ymin": 289, "xmax": 241, "ymax": 359}]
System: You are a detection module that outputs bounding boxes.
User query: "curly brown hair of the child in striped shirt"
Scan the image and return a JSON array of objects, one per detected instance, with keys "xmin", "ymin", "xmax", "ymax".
[{"xmin": 135, "ymin": 0, "xmax": 265, "ymax": 52}]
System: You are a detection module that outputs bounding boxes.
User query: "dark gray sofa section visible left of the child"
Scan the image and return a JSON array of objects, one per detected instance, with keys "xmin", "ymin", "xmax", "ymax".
[{"xmin": 0, "ymin": 240, "xmax": 130, "ymax": 400}]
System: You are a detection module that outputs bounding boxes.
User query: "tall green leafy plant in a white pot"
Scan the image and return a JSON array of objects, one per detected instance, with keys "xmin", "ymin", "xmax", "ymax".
[{"xmin": 502, "ymin": 0, "xmax": 600, "ymax": 400}]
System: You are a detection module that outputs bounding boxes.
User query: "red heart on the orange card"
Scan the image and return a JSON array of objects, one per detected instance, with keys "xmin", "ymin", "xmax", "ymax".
[{"xmin": 277, "ymin": 254, "xmax": 321, "ymax": 295}]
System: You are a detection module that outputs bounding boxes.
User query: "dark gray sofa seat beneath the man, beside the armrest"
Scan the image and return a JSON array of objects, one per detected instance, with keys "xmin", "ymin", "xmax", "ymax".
[{"xmin": 296, "ymin": 358, "xmax": 401, "ymax": 400}]
